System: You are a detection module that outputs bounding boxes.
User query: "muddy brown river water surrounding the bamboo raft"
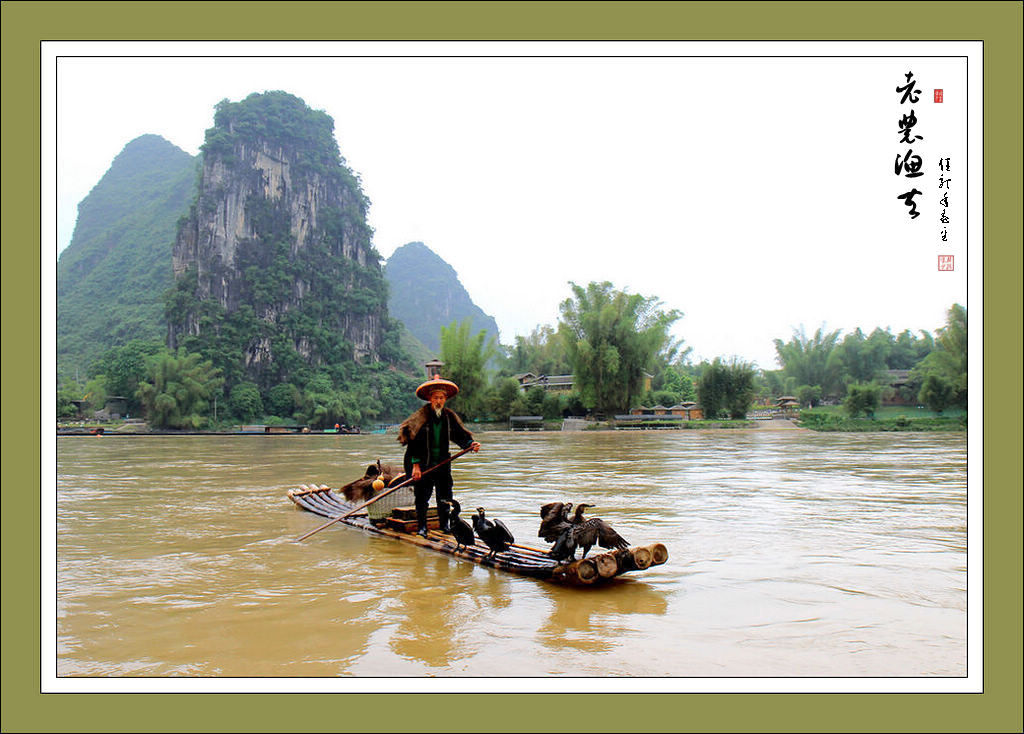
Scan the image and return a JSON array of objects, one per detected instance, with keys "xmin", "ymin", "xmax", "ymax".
[{"xmin": 55, "ymin": 431, "xmax": 967, "ymax": 677}]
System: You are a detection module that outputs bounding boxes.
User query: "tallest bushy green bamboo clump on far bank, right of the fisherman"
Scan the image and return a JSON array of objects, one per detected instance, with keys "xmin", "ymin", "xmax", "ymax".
[{"xmin": 558, "ymin": 282, "xmax": 682, "ymax": 414}]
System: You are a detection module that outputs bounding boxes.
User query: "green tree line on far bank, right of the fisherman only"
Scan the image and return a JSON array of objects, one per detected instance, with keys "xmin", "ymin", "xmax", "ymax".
[{"xmin": 441, "ymin": 283, "xmax": 967, "ymax": 420}]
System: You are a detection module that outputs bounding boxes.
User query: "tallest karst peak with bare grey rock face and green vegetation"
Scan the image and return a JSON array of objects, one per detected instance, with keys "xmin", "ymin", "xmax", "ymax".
[{"xmin": 167, "ymin": 92, "xmax": 387, "ymax": 385}]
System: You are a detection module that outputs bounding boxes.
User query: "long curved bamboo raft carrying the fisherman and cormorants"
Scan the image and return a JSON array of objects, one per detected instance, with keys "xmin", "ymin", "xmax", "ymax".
[{"xmin": 288, "ymin": 484, "xmax": 669, "ymax": 587}]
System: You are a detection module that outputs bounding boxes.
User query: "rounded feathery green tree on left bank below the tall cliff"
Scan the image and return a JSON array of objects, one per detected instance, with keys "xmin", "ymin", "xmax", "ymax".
[{"xmin": 136, "ymin": 349, "xmax": 224, "ymax": 429}]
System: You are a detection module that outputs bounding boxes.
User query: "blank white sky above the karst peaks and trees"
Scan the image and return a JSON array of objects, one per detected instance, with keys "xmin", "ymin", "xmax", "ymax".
[{"xmin": 44, "ymin": 43, "xmax": 981, "ymax": 369}]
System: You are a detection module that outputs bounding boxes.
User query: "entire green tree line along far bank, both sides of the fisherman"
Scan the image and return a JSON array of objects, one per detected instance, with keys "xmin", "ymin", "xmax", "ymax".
[{"xmin": 57, "ymin": 282, "xmax": 967, "ymax": 429}]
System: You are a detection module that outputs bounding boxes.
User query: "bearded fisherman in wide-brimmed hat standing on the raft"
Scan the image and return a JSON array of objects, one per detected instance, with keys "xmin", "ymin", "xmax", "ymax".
[{"xmin": 398, "ymin": 375, "xmax": 480, "ymax": 537}]
